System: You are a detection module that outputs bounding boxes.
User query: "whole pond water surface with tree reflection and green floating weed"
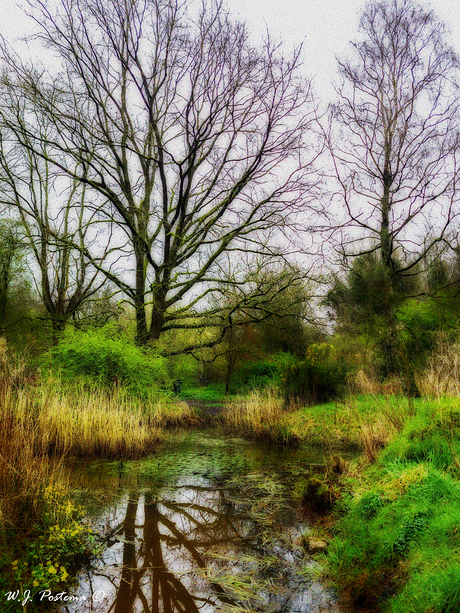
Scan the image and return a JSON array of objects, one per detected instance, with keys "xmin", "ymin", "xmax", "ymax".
[{"xmin": 60, "ymin": 431, "xmax": 339, "ymax": 613}]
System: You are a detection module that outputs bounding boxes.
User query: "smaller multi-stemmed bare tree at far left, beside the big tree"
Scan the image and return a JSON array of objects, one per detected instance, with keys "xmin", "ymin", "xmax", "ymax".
[{"xmin": 0, "ymin": 124, "xmax": 105, "ymax": 344}]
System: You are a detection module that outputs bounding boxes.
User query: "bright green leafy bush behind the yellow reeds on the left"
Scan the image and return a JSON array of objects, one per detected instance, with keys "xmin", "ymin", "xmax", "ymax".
[{"xmin": 46, "ymin": 326, "xmax": 169, "ymax": 392}]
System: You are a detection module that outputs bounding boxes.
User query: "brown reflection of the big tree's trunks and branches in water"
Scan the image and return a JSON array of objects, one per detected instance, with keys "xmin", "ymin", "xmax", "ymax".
[{"xmin": 67, "ymin": 478, "xmax": 262, "ymax": 613}]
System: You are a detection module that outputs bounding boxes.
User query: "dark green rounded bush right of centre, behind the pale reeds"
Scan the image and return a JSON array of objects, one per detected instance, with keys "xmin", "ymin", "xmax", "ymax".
[{"xmin": 281, "ymin": 343, "xmax": 350, "ymax": 404}]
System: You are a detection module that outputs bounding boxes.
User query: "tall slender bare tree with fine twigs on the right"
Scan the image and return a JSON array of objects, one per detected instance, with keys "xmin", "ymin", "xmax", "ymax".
[{"xmin": 327, "ymin": 0, "xmax": 459, "ymax": 290}]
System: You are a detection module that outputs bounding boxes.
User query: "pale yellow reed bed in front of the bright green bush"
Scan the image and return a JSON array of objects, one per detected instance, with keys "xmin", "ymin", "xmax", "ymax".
[{"xmin": 29, "ymin": 384, "xmax": 193, "ymax": 458}]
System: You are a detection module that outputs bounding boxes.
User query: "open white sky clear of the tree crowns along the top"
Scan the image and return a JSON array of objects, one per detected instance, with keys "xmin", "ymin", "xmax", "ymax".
[{"xmin": 0, "ymin": 0, "xmax": 460, "ymax": 101}]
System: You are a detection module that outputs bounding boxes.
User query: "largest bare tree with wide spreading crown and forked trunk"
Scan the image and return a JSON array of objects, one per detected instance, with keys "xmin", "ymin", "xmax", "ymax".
[{"xmin": 3, "ymin": 0, "xmax": 315, "ymax": 344}]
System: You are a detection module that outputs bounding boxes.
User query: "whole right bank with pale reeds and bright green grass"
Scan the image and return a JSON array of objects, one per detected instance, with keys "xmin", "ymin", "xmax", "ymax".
[{"xmin": 222, "ymin": 390, "xmax": 460, "ymax": 613}]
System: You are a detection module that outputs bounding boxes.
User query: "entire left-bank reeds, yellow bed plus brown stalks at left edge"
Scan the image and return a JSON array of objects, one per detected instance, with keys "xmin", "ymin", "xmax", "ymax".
[{"xmin": 0, "ymin": 339, "xmax": 194, "ymax": 525}]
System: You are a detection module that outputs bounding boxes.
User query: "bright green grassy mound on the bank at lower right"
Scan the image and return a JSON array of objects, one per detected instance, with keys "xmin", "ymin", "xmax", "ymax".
[{"xmin": 327, "ymin": 399, "xmax": 460, "ymax": 613}]
